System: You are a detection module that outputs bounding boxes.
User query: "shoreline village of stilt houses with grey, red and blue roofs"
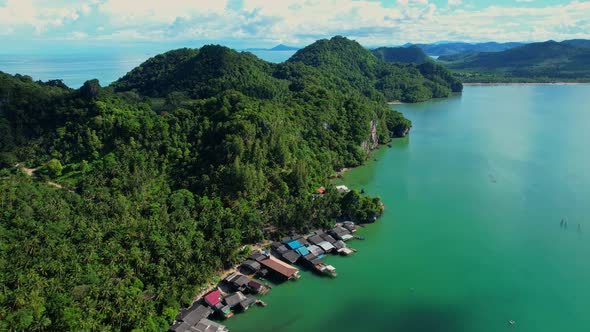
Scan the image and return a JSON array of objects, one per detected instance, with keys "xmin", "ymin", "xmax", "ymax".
[{"xmin": 169, "ymin": 186, "xmax": 364, "ymax": 332}]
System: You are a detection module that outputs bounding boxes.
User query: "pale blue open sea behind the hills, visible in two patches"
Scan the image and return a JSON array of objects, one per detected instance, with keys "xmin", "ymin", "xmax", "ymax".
[{"xmin": 0, "ymin": 51, "xmax": 295, "ymax": 89}]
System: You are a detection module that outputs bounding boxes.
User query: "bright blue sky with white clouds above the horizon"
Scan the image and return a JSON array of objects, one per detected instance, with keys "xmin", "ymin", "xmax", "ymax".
[{"xmin": 0, "ymin": 0, "xmax": 590, "ymax": 53}]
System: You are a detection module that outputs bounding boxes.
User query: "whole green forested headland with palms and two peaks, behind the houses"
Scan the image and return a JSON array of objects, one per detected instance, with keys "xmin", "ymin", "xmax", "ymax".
[{"xmin": 0, "ymin": 37, "xmax": 461, "ymax": 331}]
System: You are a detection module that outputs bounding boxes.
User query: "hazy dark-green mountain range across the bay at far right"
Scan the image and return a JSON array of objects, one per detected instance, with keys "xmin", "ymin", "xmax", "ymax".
[{"xmin": 439, "ymin": 40, "xmax": 590, "ymax": 82}]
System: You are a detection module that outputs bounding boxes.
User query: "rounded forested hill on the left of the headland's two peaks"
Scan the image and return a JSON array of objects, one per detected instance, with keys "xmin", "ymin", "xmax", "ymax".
[{"xmin": 112, "ymin": 45, "xmax": 280, "ymax": 98}]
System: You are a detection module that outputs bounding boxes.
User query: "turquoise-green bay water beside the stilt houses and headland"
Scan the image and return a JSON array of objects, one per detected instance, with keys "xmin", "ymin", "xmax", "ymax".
[{"xmin": 226, "ymin": 85, "xmax": 590, "ymax": 332}]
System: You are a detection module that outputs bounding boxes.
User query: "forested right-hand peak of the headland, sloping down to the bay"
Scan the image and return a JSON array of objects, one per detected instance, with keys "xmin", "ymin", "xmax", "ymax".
[{"xmin": 287, "ymin": 37, "xmax": 463, "ymax": 102}]
